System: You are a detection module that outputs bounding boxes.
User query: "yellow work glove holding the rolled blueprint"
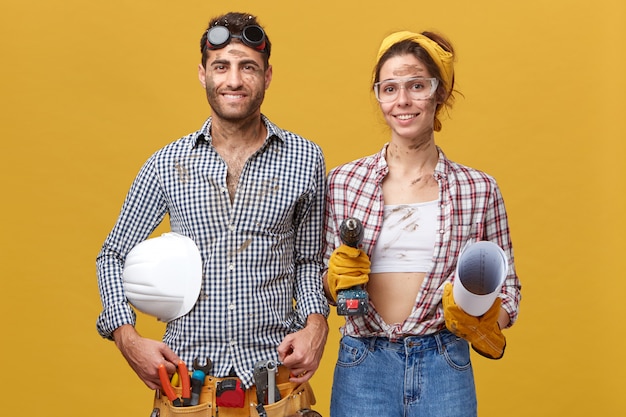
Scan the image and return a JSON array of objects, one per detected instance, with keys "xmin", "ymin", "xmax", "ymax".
[{"xmin": 442, "ymin": 283, "xmax": 506, "ymax": 359}]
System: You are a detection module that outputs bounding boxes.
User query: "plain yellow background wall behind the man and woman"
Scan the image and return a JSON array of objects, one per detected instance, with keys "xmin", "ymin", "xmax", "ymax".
[{"xmin": 0, "ymin": 0, "xmax": 626, "ymax": 417}]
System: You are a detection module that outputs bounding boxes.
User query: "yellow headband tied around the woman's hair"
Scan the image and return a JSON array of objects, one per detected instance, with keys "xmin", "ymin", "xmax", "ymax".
[{"xmin": 374, "ymin": 31, "xmax": 454, "ymax": 92}]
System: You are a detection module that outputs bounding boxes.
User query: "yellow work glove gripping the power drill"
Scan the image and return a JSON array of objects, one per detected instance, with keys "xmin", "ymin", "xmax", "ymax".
[{"xmin": 328, "ymin": 244, "xmax": 370, "ymax": 301}]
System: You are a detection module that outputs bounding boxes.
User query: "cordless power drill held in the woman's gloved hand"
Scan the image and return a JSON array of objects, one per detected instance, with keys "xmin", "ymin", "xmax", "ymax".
[{"xmin": 337, "ymin": 217, "xmax": 369, "ymax": 316}]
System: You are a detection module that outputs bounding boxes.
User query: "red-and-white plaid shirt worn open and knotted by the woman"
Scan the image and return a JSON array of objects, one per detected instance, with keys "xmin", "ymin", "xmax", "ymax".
[{"xmin": 324, "ymin": 145, "xmax": 521, "ymax": 340}]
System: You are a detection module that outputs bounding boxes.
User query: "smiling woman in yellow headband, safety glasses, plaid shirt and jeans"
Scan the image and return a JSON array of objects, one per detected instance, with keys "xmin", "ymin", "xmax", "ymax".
[{"xmin": 324, "ymin": 32, "xmax": 521, "ymax": 417}]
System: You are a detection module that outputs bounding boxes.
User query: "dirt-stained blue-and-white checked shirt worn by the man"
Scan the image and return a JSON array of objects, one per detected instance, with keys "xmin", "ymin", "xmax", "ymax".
[{"xmin": 97, "ymin": 116, "xmax": 328, "ymax": 386}]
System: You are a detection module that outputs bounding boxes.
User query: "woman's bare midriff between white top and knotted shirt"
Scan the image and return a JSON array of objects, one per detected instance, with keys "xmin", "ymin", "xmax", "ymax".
[{"xmin": 367, "ymin": 272, "xmax": 426, "ymax": 324}]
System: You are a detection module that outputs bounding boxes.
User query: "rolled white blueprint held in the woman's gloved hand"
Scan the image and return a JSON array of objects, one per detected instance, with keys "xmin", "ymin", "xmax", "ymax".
[{"xmin": 452, "ymin": 241, "xmax": 508, "ymax": 317}]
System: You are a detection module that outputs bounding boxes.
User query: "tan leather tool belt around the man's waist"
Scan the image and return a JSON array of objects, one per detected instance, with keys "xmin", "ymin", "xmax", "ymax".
[{"xmin": 152, "ymin": 366, "xmax": 319, "ymax": 417}]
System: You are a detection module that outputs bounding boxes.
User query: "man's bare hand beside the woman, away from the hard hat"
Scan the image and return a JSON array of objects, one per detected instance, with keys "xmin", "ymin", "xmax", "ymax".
[{"xmin": 278, "ymin": 314, "xmax": 328, "ymax": 384}]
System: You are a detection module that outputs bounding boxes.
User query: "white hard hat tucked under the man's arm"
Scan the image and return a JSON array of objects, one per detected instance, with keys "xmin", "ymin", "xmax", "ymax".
[{"xmin": 122, "ymin": 232, "xmax": 202, "ymax": 322}]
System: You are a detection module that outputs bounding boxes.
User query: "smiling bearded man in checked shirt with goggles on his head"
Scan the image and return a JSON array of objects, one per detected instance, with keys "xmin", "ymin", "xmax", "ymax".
[{"xmin": 97, "ymin": 13, "xmax": 328, "ymax": 414}]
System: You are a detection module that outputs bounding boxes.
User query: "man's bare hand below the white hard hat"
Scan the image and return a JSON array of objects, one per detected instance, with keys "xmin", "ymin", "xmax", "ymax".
[{"xmin": 113, "ymin": 324, "xmax": 180, "ymax": 389}]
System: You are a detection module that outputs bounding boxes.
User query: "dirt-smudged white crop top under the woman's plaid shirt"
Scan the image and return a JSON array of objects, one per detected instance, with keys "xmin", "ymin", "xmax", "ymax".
[{"xmin": 370, "ymin": 200, "xmax": 439, "ymax": 273}]
